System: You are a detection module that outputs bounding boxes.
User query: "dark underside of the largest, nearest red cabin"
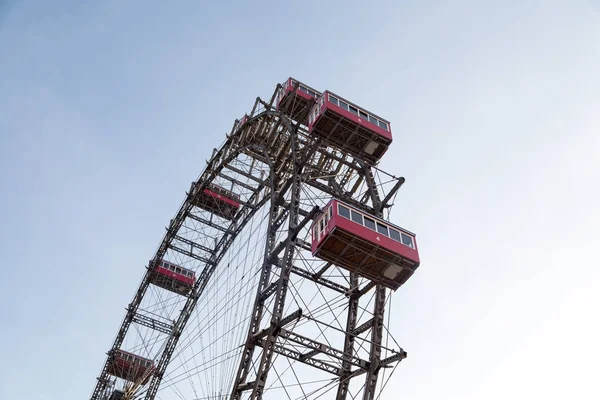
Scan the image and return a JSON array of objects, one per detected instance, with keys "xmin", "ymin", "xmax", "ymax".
[{"xmin": 315, "ymin": 229, "xmax": 418, "ymax": 290}]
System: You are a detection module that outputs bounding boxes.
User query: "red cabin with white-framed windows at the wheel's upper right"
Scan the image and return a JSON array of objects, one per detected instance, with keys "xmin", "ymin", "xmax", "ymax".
[{"xmin": 308, "ymin": 91, "xmax": 392, "ymax": 164}]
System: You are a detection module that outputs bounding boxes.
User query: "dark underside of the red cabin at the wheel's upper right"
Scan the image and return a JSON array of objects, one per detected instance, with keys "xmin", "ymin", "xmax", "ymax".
[{"xmin": 312, "ymin": 110, "xmax": 391, "ymax": 164}]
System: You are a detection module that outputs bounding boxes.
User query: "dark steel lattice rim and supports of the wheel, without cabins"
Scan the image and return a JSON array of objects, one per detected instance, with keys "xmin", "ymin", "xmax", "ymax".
[{"xmin": 91, "ymin": 80, "xmax": 406, "ymax": 400}]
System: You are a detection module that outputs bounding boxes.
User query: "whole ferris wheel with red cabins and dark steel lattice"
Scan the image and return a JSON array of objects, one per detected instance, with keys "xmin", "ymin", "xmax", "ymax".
[{"xmin": 91, "ymin": 78, "xmax": 420, "ymax": 400}]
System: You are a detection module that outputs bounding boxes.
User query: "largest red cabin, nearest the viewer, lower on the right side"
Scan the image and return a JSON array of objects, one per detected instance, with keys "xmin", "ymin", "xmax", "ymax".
[{"xmin": 312, "ymin": 199, "xmax": 420, "ymax": 290}]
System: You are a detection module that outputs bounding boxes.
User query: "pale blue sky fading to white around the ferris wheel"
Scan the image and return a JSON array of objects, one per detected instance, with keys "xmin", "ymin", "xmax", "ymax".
[{"xmin": 0, "ymin": 0, "xmax": 600, "ymax": 400}]
